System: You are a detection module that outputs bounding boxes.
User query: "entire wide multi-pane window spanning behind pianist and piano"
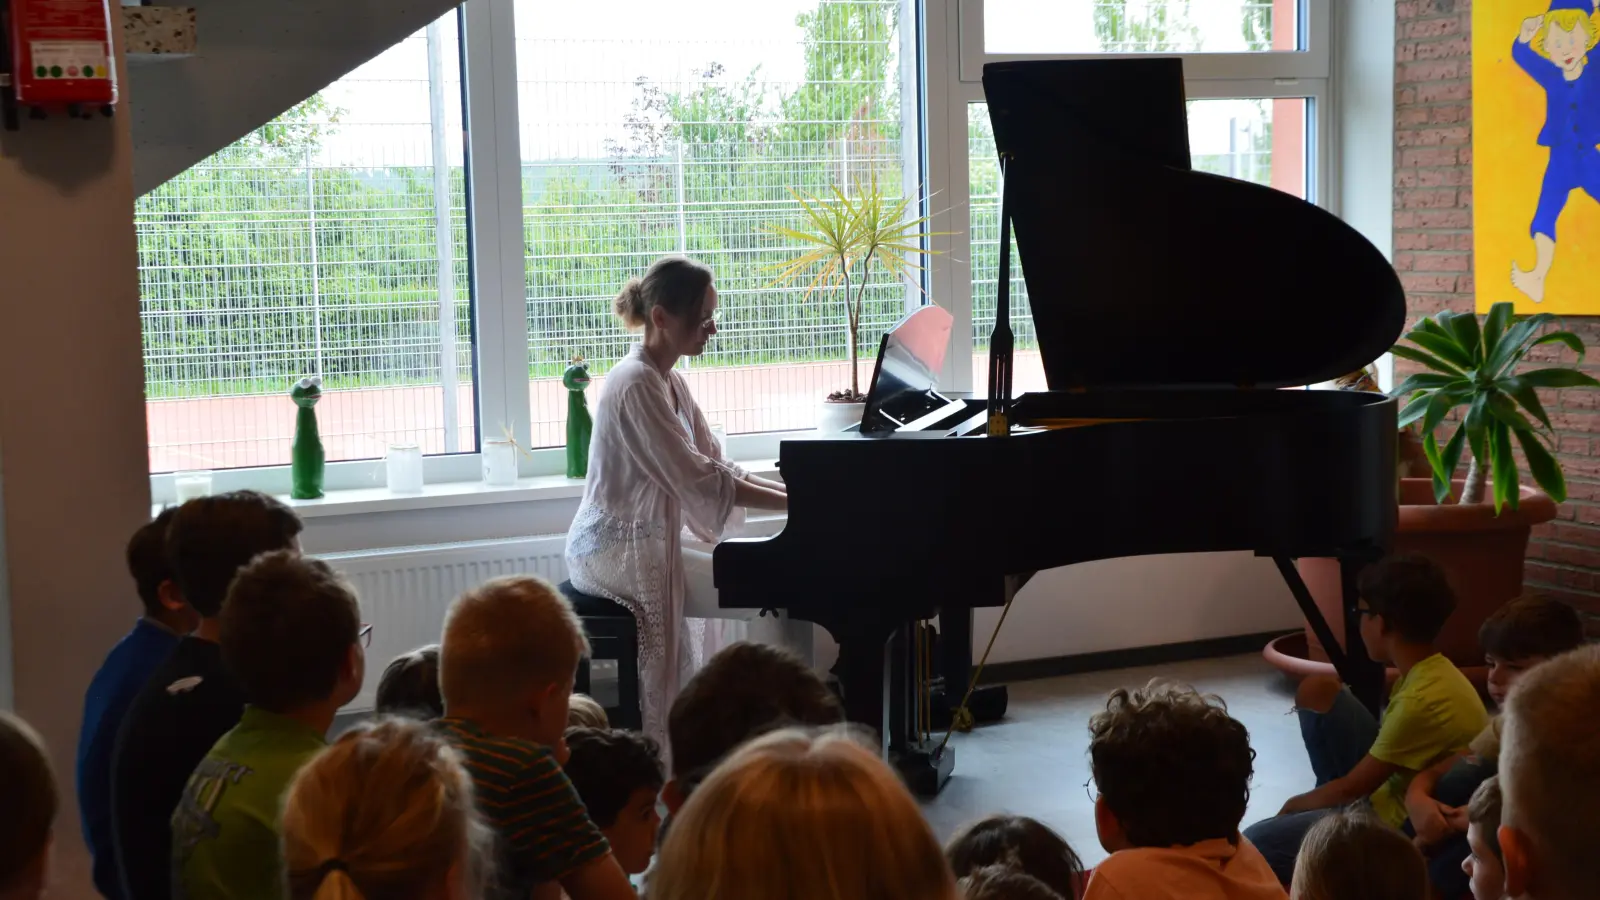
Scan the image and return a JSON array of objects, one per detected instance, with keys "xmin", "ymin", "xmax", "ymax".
[{"xmin": 138, "ymin": 0, "xmax": 1331, "ymax": 498}]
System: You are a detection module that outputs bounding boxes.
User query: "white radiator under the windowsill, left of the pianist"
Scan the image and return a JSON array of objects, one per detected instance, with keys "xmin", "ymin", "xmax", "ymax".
[{"xmin": 322, "ymin": 535, "xmax": 566, "ymax": 713}]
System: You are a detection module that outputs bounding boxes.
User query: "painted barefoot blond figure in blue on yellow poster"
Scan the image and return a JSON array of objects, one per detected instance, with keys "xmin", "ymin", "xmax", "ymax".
[{"xmin": 1510, "ymin": 0, "xmax": 1600, "ymax": 303}]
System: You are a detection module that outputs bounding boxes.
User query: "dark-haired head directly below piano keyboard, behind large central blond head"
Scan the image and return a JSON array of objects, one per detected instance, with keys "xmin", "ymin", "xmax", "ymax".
[{"xmin": 664, "ymin": 641, "xmax": 845, "ymax": 810}]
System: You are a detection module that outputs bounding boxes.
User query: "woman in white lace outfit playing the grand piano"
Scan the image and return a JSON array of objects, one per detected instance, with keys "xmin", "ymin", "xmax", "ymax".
[{"xmin": 566, "ymin": 256, "xmax": 789, "ymax": 743}]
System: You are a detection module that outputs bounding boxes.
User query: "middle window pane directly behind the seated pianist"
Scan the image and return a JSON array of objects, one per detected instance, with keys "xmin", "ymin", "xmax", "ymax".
[{"xmin": 517, "ymin": 0, "xmax": 920, "ymax": 447}]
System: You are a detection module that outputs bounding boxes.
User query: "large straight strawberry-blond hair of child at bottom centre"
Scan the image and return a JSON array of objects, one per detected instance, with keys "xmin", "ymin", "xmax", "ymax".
[{"xmin": 650, "ymin": 730, "xmax": 957, "ymax": 900}]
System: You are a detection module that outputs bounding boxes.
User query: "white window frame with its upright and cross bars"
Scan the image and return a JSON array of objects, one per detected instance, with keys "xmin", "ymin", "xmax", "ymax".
[{"xmin": 150, "ymin": 0, "xmax": 1338, "ymax": 503}]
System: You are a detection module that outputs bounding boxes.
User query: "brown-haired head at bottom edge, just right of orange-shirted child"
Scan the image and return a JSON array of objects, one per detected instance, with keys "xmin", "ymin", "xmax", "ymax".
[{"xmin": 1290, "ymin": 807, "xmax": 1429, "ymax": 900}]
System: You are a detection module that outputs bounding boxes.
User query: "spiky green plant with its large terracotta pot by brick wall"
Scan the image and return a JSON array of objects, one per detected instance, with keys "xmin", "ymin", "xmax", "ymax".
[{"xmin": 1267, "ymin": 303, "xmax": 1600, "ymax": 674}]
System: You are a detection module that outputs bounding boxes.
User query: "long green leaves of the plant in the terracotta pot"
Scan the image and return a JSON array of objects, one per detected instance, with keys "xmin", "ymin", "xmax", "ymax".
[{"xmin": 1394, "ymin": 303, "xmax": 1600, "ymax": 516}]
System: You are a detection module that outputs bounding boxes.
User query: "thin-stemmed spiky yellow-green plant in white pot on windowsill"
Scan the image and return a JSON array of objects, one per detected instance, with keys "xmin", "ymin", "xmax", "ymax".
[{"xmin": 771, "ymin": 176, "xmax": 936, "ymax": 432}]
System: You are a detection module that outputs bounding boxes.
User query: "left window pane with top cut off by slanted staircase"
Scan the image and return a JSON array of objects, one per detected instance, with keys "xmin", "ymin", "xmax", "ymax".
[{"xmin": 136, "ymin": 13, "xmax": 478, "ymax": 472}]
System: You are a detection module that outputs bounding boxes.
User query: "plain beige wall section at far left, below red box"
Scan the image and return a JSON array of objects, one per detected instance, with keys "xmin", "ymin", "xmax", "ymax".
[{"xmin": 0, "ymin": 29, "xmax": 150, "ymax": 897}]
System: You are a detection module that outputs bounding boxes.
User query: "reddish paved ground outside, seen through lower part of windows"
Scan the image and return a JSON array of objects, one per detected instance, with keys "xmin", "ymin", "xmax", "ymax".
[{"xmin": 146, "ymin": 352, "xmax": 1045, "ymax": 472}]
